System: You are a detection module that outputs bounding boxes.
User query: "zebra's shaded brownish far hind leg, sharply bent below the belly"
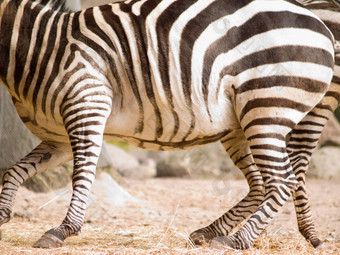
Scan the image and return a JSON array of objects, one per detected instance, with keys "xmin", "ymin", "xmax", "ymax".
[{"xmin": 190, "ymin": 129, "xmax": 264, "ymax": 245}]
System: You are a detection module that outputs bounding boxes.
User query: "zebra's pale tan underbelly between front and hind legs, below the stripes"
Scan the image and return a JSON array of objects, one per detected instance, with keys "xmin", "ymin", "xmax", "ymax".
[{"xmin": 104, "ymin": 97, "xmax": 239, "ymax": 150}]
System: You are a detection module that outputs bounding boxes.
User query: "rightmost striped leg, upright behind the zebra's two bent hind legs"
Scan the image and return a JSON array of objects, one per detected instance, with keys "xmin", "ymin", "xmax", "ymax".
[{"xmin": 287, "ymin": 105, "xmax": 332, "ymax": 248}]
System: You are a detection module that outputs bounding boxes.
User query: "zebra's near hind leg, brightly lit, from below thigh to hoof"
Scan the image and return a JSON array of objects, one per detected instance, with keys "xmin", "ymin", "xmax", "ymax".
[{"xmin": 211, "ymin": 137, "xmax": 298, "ymax": 249}]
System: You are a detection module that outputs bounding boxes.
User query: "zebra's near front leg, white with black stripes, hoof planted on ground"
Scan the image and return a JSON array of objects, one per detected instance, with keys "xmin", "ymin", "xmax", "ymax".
[{"xmin": 33, "ymin": 95, "xmax": 109, "ymax": 248}]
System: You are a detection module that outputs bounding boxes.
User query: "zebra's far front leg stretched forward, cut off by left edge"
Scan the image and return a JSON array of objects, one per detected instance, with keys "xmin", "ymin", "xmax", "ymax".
[{"xmin": 0, "ymin": 142, "xmax": 72, "ymax": 225}]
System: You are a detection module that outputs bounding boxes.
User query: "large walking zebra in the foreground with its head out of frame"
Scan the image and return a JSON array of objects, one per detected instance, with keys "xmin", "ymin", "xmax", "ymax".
[{"xmin": 0, "ymin": 0, "xmax": 340, "ymax": 249}]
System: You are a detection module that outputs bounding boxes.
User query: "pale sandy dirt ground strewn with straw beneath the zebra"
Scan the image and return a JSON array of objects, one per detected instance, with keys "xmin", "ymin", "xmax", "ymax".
[{"xmin": 0, "ymin": 176, "xmax": 340, "ymax": 254}]
